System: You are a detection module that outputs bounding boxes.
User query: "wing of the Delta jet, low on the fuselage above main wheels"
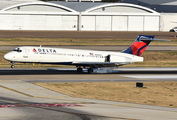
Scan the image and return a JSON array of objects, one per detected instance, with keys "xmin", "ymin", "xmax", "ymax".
[{"xmin": 72, "ymin": 62, "xmax": 130, "ymax": 68}]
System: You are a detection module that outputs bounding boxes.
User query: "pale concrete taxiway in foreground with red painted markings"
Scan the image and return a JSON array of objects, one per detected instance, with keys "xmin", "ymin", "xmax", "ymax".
[{"xmin": 0, "ymin": 80, "xmax": 177, "ymax": 120}]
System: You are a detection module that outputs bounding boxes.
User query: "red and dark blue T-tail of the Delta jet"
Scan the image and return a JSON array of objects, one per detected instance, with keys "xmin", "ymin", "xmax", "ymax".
[{"xmin": 122, "ymin": 35, "xmax": 169, "ymax": 56}]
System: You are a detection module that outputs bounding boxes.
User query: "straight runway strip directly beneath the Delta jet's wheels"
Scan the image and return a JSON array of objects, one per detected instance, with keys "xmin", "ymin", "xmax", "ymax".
[{"xmin": 0, "ymin": 67, "xmax": 177, "ymax": 82}]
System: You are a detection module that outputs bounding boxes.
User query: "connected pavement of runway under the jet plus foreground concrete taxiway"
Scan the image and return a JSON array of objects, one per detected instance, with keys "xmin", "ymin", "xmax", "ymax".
[{"xmin": 0, "ymin": 68, "xmax": 177, "ymax": 120}]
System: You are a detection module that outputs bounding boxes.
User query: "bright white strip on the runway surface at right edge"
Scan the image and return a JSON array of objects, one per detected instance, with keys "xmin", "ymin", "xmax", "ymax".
[{"xmin": 120, "ymin": 75, "xmax": 177, "ymax": 79}]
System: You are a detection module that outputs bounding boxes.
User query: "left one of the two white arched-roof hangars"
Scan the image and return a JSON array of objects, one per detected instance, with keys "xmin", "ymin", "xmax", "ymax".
[{"xmin": 0, "ymin": 1, "xmax": 79, "ymax": 31}]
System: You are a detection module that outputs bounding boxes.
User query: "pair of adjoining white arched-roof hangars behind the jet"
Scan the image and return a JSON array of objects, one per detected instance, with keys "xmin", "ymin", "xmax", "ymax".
[{"xmin": 0, "ymin": 0, "xmax": 174, "ymax": 31}]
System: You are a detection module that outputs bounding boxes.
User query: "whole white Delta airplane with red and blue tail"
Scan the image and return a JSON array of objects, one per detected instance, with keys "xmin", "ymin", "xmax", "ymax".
[{"xmin": 4, "ymin": 35, "xmax": 168, "ymax": 73}]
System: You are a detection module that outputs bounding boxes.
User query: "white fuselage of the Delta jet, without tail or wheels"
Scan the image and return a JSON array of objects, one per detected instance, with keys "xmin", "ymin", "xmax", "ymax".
[{"xmin": 4, "ymin": 46, "xmax": 143, "ymax": 65}]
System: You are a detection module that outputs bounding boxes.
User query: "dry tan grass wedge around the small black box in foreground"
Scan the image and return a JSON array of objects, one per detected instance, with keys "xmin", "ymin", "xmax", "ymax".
[{"xmin": 34, "ymin": 82, "xmax": 177, "ymax": 107}]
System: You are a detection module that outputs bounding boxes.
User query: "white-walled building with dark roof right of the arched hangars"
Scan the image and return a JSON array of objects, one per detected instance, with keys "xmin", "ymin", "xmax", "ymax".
[{"xmin": 121, "ymin": 0, "xmax": 177, "ymax": 31}]
